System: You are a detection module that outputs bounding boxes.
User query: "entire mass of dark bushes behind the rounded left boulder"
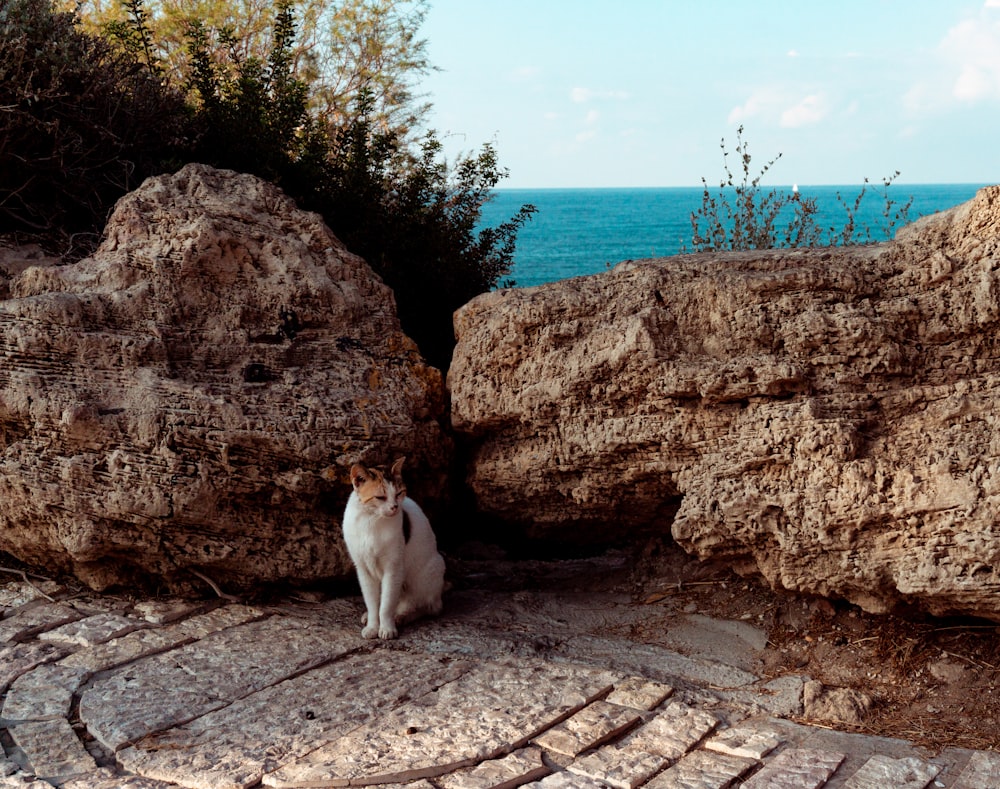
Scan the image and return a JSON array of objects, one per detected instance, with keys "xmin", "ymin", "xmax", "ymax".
[{"xmin": 0, "ymin": 0, "xmax": 534, "ymax": 368}]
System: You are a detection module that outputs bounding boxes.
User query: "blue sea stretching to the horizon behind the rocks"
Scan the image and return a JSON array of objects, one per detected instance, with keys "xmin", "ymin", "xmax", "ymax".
[{"xmin": 482, "ymin": 184, "xmax": 983, "ymax": 287}]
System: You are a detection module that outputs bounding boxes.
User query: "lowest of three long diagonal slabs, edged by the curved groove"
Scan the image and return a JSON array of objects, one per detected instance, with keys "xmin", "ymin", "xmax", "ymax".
[{"xmin": 264, "ymin": 659, "xmax": 619, "ymax": 789}]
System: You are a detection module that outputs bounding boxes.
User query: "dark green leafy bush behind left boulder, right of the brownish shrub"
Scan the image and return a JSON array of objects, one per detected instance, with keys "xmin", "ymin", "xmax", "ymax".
[{"xmin": 183, "ymin": 0, "xmax": 534, "ymax": 369}]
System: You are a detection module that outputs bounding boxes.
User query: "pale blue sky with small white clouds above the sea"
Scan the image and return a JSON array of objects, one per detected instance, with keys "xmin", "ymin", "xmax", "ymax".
[{"xmin": 419, "ymin": 0, "xmax": 1000, "ymax": 188}]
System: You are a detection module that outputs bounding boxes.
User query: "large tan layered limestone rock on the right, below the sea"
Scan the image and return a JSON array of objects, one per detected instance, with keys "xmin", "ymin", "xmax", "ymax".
[{"xmin": 449, "ymin": 187, "xmax": 1000, "ymax": 621}]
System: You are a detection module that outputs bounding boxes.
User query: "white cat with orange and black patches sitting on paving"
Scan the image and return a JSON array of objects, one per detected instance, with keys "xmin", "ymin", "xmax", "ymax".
[{"xmin": 344, "ymin": 458, "xmax": 445, "ymax": 639}]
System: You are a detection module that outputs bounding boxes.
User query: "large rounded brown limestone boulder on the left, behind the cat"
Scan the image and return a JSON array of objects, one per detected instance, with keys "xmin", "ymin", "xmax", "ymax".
[{"xmin": 0, "ymin": 165, "xmax": 449, "ymax": 589}]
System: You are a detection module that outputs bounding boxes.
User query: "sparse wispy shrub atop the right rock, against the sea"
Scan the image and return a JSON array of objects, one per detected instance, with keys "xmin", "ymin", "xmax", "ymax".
[{"xmin": 691, "ymin": 126, "xmax": 913, "ymax": 252}]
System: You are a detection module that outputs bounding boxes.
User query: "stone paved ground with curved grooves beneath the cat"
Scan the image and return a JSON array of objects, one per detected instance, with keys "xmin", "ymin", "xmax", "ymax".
[{"xmin": 0, "ymin": 582, "xmax": 1000, "ymax": 789}]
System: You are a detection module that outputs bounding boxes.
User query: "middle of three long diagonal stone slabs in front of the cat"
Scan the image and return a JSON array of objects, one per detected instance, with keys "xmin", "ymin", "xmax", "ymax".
[{"xmin": 118, "ymin": 650, "xmax": 470, "ymax": 788}]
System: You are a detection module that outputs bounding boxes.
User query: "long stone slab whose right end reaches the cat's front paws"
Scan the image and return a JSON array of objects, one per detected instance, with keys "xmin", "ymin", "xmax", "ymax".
[{"xmin": 80, "ymin": 617, "xmax": 361, "ymax": 751}]
